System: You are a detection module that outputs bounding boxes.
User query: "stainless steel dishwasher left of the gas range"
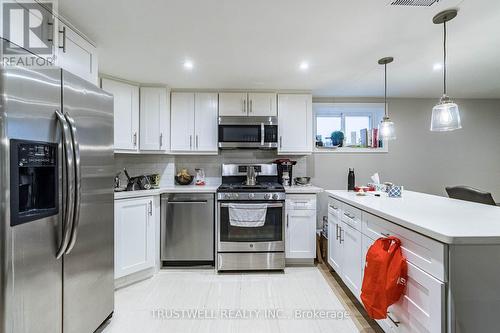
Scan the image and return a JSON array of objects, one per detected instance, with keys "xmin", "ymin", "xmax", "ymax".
[{"xmin": 161, "ymin": 193, "xmax": 215, "ymax": 266}]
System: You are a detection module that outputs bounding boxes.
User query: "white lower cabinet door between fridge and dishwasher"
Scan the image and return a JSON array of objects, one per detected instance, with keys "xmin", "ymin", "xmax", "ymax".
[{"xmin": 115, "ymin": 197, "xmax": 156, "ymax": 279}]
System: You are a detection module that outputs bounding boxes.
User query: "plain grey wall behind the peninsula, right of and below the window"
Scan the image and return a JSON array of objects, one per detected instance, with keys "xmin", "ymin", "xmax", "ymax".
[{"xmin": 308, "ymin": 99, "xmax": 500, "ymax": 198}]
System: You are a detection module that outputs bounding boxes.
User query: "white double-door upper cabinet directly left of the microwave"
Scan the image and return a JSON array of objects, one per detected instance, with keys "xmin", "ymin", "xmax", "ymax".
[{"xmin": 170, "ymin": 92, "xmax": 218, "ymax": 155}]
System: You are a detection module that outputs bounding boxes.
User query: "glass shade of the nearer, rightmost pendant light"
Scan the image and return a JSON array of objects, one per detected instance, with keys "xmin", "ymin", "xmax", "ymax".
[{"xmin": 431, "ymin": 95, "xmax": 462, "ymax": 132}]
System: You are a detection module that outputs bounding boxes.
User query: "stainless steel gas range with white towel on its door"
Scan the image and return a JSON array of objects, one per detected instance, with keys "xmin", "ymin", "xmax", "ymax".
[{"xmin": 216, "ymin": 164, "xmax": 286, "ymax": 271}]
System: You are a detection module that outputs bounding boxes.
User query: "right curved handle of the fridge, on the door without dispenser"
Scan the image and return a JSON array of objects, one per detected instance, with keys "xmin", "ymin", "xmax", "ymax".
[{"xmin": 64, "ymin": 112, "xmax": 82, "ymax": 254}]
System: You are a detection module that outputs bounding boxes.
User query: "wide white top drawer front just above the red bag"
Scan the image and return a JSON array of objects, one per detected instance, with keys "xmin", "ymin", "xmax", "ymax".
[{"xmin": 362, "ymin": 212, "xmax": 446, "ymax": 281}]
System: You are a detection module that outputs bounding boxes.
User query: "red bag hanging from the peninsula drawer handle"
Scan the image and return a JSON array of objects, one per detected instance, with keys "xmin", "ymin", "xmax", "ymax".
[{"xmin": 361, "ymin": 237, "xmax": 408, "ymax": 319}]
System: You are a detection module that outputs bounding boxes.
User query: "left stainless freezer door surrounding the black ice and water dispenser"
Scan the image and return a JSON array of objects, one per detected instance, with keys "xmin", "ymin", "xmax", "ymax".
[{"xmin": 0, "ymin": 67, "xmax": 63, "ymax": 333}]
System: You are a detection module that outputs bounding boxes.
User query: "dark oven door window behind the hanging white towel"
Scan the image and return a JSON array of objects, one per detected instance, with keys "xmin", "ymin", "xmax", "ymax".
[{"xmin": 219, "ymin": 202, "xmax": 284, "ymax": 243}]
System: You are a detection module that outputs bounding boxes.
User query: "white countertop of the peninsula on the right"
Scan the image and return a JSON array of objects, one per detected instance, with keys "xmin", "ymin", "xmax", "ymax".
[{"xmin": 326, "ymin": 191, "xmax": 500, "ymax": 244}]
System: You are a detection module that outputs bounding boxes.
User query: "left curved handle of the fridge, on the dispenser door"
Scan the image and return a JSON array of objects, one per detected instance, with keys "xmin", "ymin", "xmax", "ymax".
[{"xmin": 56, "ymin": 110, "xmax": 75, "ymax": 259}]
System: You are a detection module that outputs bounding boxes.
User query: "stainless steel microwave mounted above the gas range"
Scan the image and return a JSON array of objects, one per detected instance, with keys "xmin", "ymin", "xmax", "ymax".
[{"xmin": 219, "ymin": 116, "xmax": 278, "ymax": 149}]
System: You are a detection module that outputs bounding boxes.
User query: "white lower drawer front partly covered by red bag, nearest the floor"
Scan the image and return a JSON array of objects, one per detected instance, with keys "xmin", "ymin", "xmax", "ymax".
[{"xmin": 386, "ymin": 263, "xmax": 444, "ymax": 333}]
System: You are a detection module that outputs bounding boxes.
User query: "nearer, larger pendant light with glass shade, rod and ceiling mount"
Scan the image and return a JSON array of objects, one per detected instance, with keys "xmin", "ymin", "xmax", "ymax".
[{"xmin": 431, "ymin": 9, "xmax": 462, "ymax": 132}]
